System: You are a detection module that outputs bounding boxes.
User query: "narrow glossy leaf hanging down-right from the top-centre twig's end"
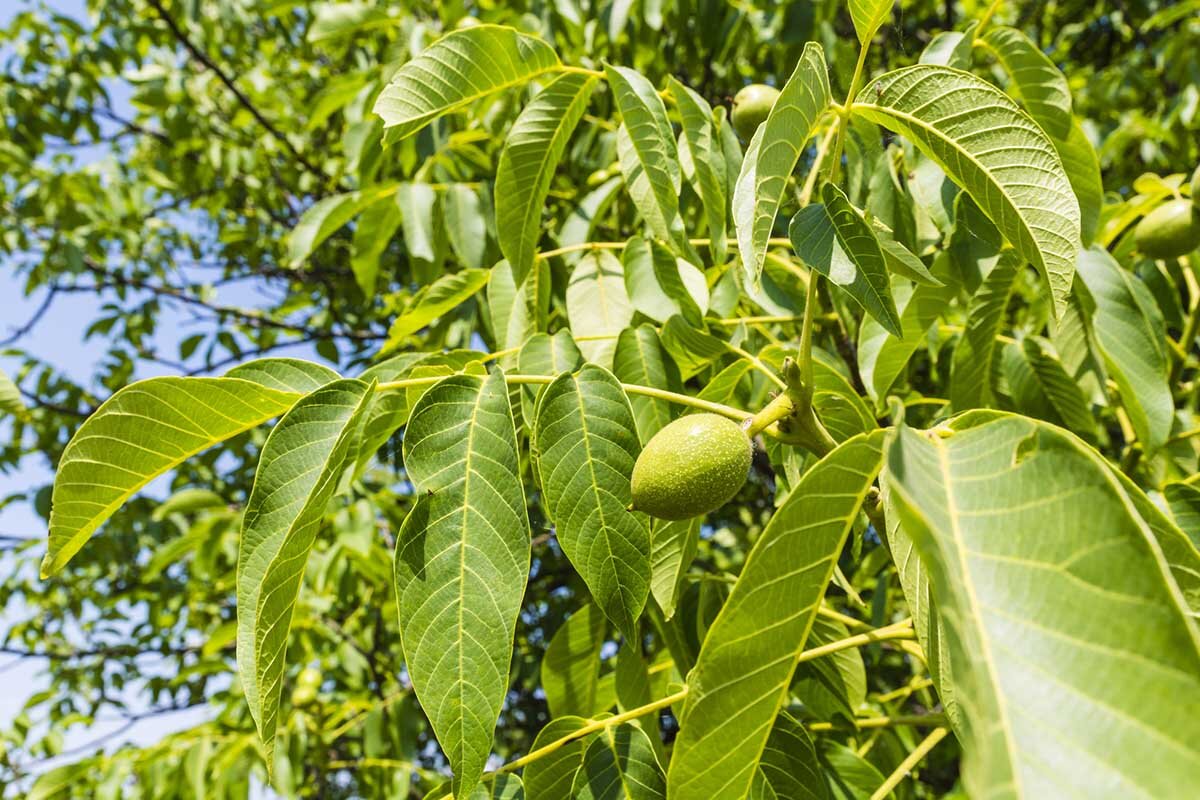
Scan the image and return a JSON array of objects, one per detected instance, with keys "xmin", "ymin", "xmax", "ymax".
[{"xmin": 605, "ymin": 64, "xmax": 689, "ymax": 253}]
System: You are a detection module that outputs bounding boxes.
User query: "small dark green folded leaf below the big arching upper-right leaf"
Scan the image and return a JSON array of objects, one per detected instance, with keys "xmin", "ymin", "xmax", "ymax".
[{"xmin": 787, "ymin": 184, "xmax": 900, "ymax": 336}]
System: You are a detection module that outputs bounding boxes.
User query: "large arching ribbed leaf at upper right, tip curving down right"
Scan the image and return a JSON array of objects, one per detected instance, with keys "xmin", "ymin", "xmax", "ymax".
[{"xmin": 852, "ymin": 65, "xmax": 1080, "ymax": 317}]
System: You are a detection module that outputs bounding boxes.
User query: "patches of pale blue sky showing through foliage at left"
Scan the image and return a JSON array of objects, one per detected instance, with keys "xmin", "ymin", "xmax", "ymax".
[{"xmin": 0, "ymin": 0, "xmax": 316, "ymax": 782}]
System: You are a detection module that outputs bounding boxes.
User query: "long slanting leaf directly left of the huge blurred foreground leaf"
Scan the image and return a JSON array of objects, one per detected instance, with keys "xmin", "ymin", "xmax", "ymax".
[{"xmin": 668, "ymin": 432, "xmax": 883, "ymax": 799}]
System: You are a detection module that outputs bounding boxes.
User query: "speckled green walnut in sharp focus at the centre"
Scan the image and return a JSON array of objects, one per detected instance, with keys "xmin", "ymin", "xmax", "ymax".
[{"xmin": 632, "ymin": 414, "xmax": 754, "ymax": 519}]
